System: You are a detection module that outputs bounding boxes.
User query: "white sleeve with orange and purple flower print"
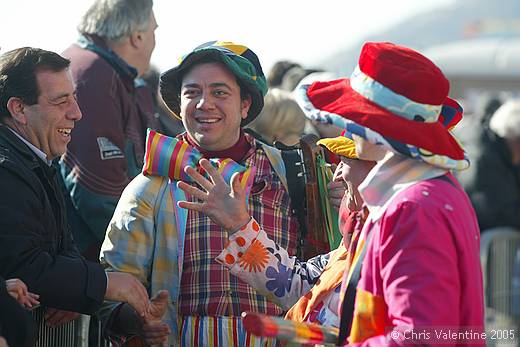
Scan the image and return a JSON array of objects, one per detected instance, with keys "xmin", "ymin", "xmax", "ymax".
[{"xmin": 217, "ymin": 219, "xmax": 330, "ymax": 309}]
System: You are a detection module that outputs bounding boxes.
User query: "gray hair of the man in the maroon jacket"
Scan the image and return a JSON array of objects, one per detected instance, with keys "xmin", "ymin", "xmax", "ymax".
[{"xmin": 78, "ymin": 0, "xmax": 153, "ymax": 42}]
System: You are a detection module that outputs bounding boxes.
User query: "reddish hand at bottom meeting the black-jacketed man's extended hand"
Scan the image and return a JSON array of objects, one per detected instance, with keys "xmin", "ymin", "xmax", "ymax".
[{"xmin": 143, "ymin": 290, "xmax": 171, "ymax": 345}]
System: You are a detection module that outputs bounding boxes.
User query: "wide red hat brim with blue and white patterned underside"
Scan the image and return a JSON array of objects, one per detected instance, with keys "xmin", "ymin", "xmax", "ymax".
[{"xmin": 297, "ymin": 78, "xmax": 469, "ymax": 170}]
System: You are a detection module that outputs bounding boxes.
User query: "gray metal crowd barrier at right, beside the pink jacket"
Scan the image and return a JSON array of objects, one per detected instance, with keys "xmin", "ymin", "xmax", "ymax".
[{"xmin": 480, "ymin": 227, "xmax": 520, "ymax": 347}]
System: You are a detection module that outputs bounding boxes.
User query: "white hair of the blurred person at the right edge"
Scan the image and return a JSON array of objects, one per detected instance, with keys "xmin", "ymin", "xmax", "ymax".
[{"xmin": 489, "ymin": 100, "xmax": 520, "ymax": 140}]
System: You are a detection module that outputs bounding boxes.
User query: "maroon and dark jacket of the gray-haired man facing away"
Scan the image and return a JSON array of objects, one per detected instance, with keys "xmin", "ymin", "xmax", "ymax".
[{"xmin": 60, "ymin": 35, "xmax": 158, "ymax": 260}]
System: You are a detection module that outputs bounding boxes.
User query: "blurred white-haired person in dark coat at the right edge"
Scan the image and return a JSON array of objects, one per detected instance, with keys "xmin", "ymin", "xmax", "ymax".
[{"xmin": 458, "ymin": 100, "xmax": 520, "ymax": 232}]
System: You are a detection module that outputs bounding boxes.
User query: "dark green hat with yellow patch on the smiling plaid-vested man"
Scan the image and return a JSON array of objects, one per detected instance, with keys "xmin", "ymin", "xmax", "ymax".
[{"xmin": 160, "ymin": 41, "xmax": 267, "ymax": 126}]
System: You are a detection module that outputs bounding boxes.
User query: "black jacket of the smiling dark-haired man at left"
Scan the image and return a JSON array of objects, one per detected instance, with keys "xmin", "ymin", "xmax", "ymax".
[{"xmin": 0, "ymin": 125, "xmax": 107, "ymax": 314}]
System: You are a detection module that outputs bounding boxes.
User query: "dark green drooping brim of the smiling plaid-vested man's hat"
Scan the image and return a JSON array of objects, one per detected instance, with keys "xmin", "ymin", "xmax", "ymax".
[{"xmin": 160, "ymin": 49, "xmax": 264, "ymax": 126}]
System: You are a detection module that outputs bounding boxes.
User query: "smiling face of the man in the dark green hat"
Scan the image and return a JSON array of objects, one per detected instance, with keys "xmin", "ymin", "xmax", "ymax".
[{"xmin": 180, "ymin": 62, "xmax": 251, "ymax": 151}]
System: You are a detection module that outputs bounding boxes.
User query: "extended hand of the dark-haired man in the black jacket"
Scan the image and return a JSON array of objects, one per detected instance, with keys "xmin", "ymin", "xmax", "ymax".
[{"xmin": 105, "ymin": 272, "xmax": 149, "ymax": 317}]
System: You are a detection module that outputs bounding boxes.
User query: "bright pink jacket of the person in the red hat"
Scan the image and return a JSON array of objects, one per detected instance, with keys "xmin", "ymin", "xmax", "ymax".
[{"xmin": 349, "ymin": 173, "xmax": 485, "ymax": 346}]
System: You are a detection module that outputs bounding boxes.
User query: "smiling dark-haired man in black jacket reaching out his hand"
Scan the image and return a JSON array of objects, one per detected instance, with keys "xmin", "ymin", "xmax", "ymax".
[{"xmin": 0, "ymin": 47, "xmax": 148, "ymax": 334}]
